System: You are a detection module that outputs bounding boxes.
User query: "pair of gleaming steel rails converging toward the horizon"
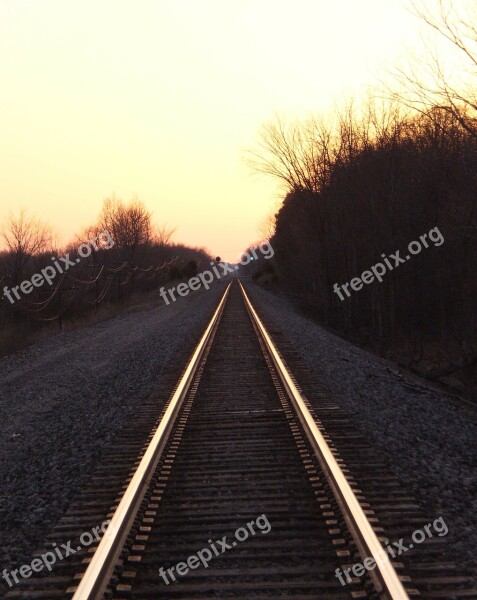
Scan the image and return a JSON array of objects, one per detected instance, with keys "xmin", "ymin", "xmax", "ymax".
[{"xmin": 73, "ymin": 280, "xmax": 409, "ymax": 600}]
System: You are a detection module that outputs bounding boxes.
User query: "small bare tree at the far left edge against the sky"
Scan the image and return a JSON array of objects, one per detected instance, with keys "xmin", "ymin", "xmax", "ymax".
[{"xmin": 1, "ymin": 209, "xmax": 53, "ymax": 284}]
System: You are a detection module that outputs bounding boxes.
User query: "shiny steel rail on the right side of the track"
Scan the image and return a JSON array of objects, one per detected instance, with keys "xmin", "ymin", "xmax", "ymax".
[{"xmin": 239, "ymin": 280, "xmax": 409, "ymax": 600}]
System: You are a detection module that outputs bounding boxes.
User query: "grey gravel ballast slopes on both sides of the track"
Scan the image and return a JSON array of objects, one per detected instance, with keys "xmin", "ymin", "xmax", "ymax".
[{"xmin": 0, "ymin": 284, "xmax": 477, "ymax": 584}]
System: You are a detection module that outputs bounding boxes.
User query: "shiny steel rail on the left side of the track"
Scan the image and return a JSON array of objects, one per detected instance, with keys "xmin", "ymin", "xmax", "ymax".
[{"xmin": 73, "ymin": 283, "xmax": 231, "ymax": 600}]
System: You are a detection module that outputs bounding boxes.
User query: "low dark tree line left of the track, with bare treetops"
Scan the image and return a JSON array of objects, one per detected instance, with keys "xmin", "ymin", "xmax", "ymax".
[{"xmin": 0, "ymin": 197, "xmax": 210, "ymax": 338}]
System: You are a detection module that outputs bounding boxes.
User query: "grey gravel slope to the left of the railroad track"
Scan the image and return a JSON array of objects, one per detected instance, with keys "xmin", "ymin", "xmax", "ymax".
[{"xmin": 0, "ymin": 285, "xmax": 224, "ymax": 571}]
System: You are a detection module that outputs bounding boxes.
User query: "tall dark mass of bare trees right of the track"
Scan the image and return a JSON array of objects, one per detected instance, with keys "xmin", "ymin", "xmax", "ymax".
[{"xmin": 251, "ymin": 1, "xmax": 477, "ymax": 374}]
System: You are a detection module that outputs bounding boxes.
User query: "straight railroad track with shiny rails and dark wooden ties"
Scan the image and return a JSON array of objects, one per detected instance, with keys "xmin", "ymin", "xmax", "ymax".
[{"xmin": 6, "ymin": 282, "xmax": 477, "ymax": 600}]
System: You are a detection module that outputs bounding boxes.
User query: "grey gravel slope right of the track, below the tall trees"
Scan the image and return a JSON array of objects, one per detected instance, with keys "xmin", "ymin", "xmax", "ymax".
[{"xmin": 247, "ymin": 285, "xmax": 477, "ymax": 576}]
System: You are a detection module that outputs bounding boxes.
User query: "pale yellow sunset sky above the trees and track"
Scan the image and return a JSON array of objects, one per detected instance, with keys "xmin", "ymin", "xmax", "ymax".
[{"xmin": 0, "ymin": 0, "xmax": 438, "ymax": 260}]
